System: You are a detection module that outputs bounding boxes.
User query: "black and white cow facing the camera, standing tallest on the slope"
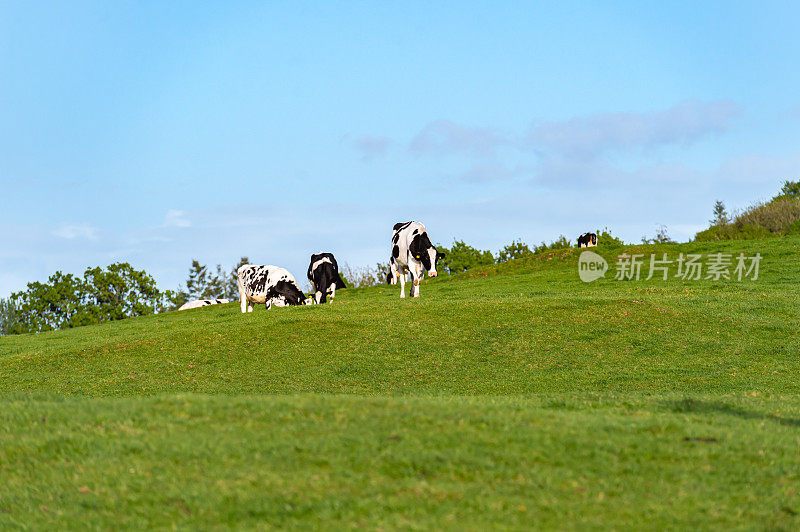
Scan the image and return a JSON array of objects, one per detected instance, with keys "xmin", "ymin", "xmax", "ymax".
[{"xmin": 389, "ymin": 218, "xmax": 444, "ymax": 297}]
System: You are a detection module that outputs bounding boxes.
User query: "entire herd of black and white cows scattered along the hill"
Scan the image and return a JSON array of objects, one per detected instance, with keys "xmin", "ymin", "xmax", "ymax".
[{"xmin": 179, "ymin": 221, "xmax": 597, "ymax": 313}]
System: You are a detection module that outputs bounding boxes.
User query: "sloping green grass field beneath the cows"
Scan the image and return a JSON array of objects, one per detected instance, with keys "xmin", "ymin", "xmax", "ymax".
[{"xmin": 0, "ymin": 237, "xmax": 800, "ymax": 529}]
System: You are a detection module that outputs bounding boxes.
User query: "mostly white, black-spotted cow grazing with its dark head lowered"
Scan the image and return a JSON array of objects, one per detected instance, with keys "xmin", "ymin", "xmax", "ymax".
[{"xmin": 236, "ymin": 264, "xmax": 311, "ymax": 313}]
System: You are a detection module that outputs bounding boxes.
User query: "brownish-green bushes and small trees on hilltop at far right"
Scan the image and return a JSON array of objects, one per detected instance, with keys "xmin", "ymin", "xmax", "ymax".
[{"xmin": 695, "ymin": 181, "xmax": 800, "ymax": 241}]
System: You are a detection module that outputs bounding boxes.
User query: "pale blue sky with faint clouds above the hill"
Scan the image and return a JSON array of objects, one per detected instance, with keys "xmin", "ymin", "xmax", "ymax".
[{"xmin": 0, "ymin": 2, "xmax": 800, "ymax": 297}]
